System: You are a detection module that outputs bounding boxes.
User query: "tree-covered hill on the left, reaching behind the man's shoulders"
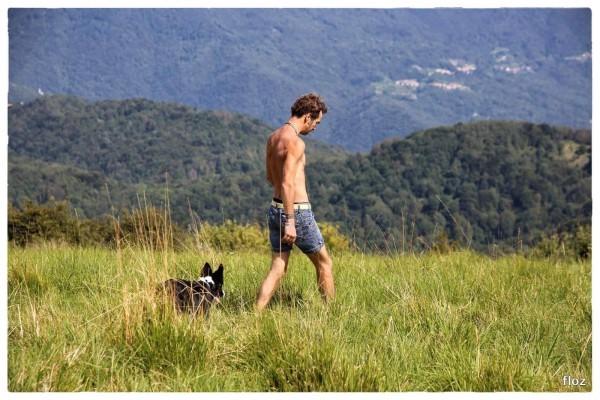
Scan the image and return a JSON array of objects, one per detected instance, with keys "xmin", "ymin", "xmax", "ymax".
[{"xmin": 8, "ymin": 96, "xmax": 346, "ymax": 223}]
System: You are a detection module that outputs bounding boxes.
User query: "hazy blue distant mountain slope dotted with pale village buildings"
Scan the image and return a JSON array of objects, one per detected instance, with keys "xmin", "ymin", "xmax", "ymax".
[{"xmin": 9, "ymin": 9, "xmax": 592, "ymax": 151}]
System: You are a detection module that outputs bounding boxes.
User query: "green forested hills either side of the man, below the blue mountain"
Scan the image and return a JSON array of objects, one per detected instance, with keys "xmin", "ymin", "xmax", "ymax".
[{"xmin": 8, "ymin": 96, "xmax": 591, "ymax": 250}]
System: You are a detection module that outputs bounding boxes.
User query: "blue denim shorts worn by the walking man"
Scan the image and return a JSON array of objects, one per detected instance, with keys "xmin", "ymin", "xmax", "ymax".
[{"xmin": 268, "ymin": 206, "xmax": 325, "ymax": 254}]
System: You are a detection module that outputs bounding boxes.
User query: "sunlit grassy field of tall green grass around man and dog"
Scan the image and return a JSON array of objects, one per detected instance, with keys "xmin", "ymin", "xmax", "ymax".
[{"xmin": 8, "ymin": 245, "xmax": 592, "ymax": 391}]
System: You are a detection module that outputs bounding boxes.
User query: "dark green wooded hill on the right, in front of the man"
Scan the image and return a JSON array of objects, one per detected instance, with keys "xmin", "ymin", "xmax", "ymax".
[{"xmin": 309, "ymin": 121, "xmax": 592, "ymax": 249}]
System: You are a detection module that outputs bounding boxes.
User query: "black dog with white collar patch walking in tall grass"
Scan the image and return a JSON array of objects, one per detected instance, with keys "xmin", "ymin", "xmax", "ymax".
[{"xmin": 162, "ymin": 263, "xmax": 225, "ymax": 316}]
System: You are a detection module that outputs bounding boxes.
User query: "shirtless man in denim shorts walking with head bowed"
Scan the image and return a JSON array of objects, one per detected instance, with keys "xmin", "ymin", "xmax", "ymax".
[{"xmin": 256, "ymin": 93, "xmax": 334, "ymax": 311}]
